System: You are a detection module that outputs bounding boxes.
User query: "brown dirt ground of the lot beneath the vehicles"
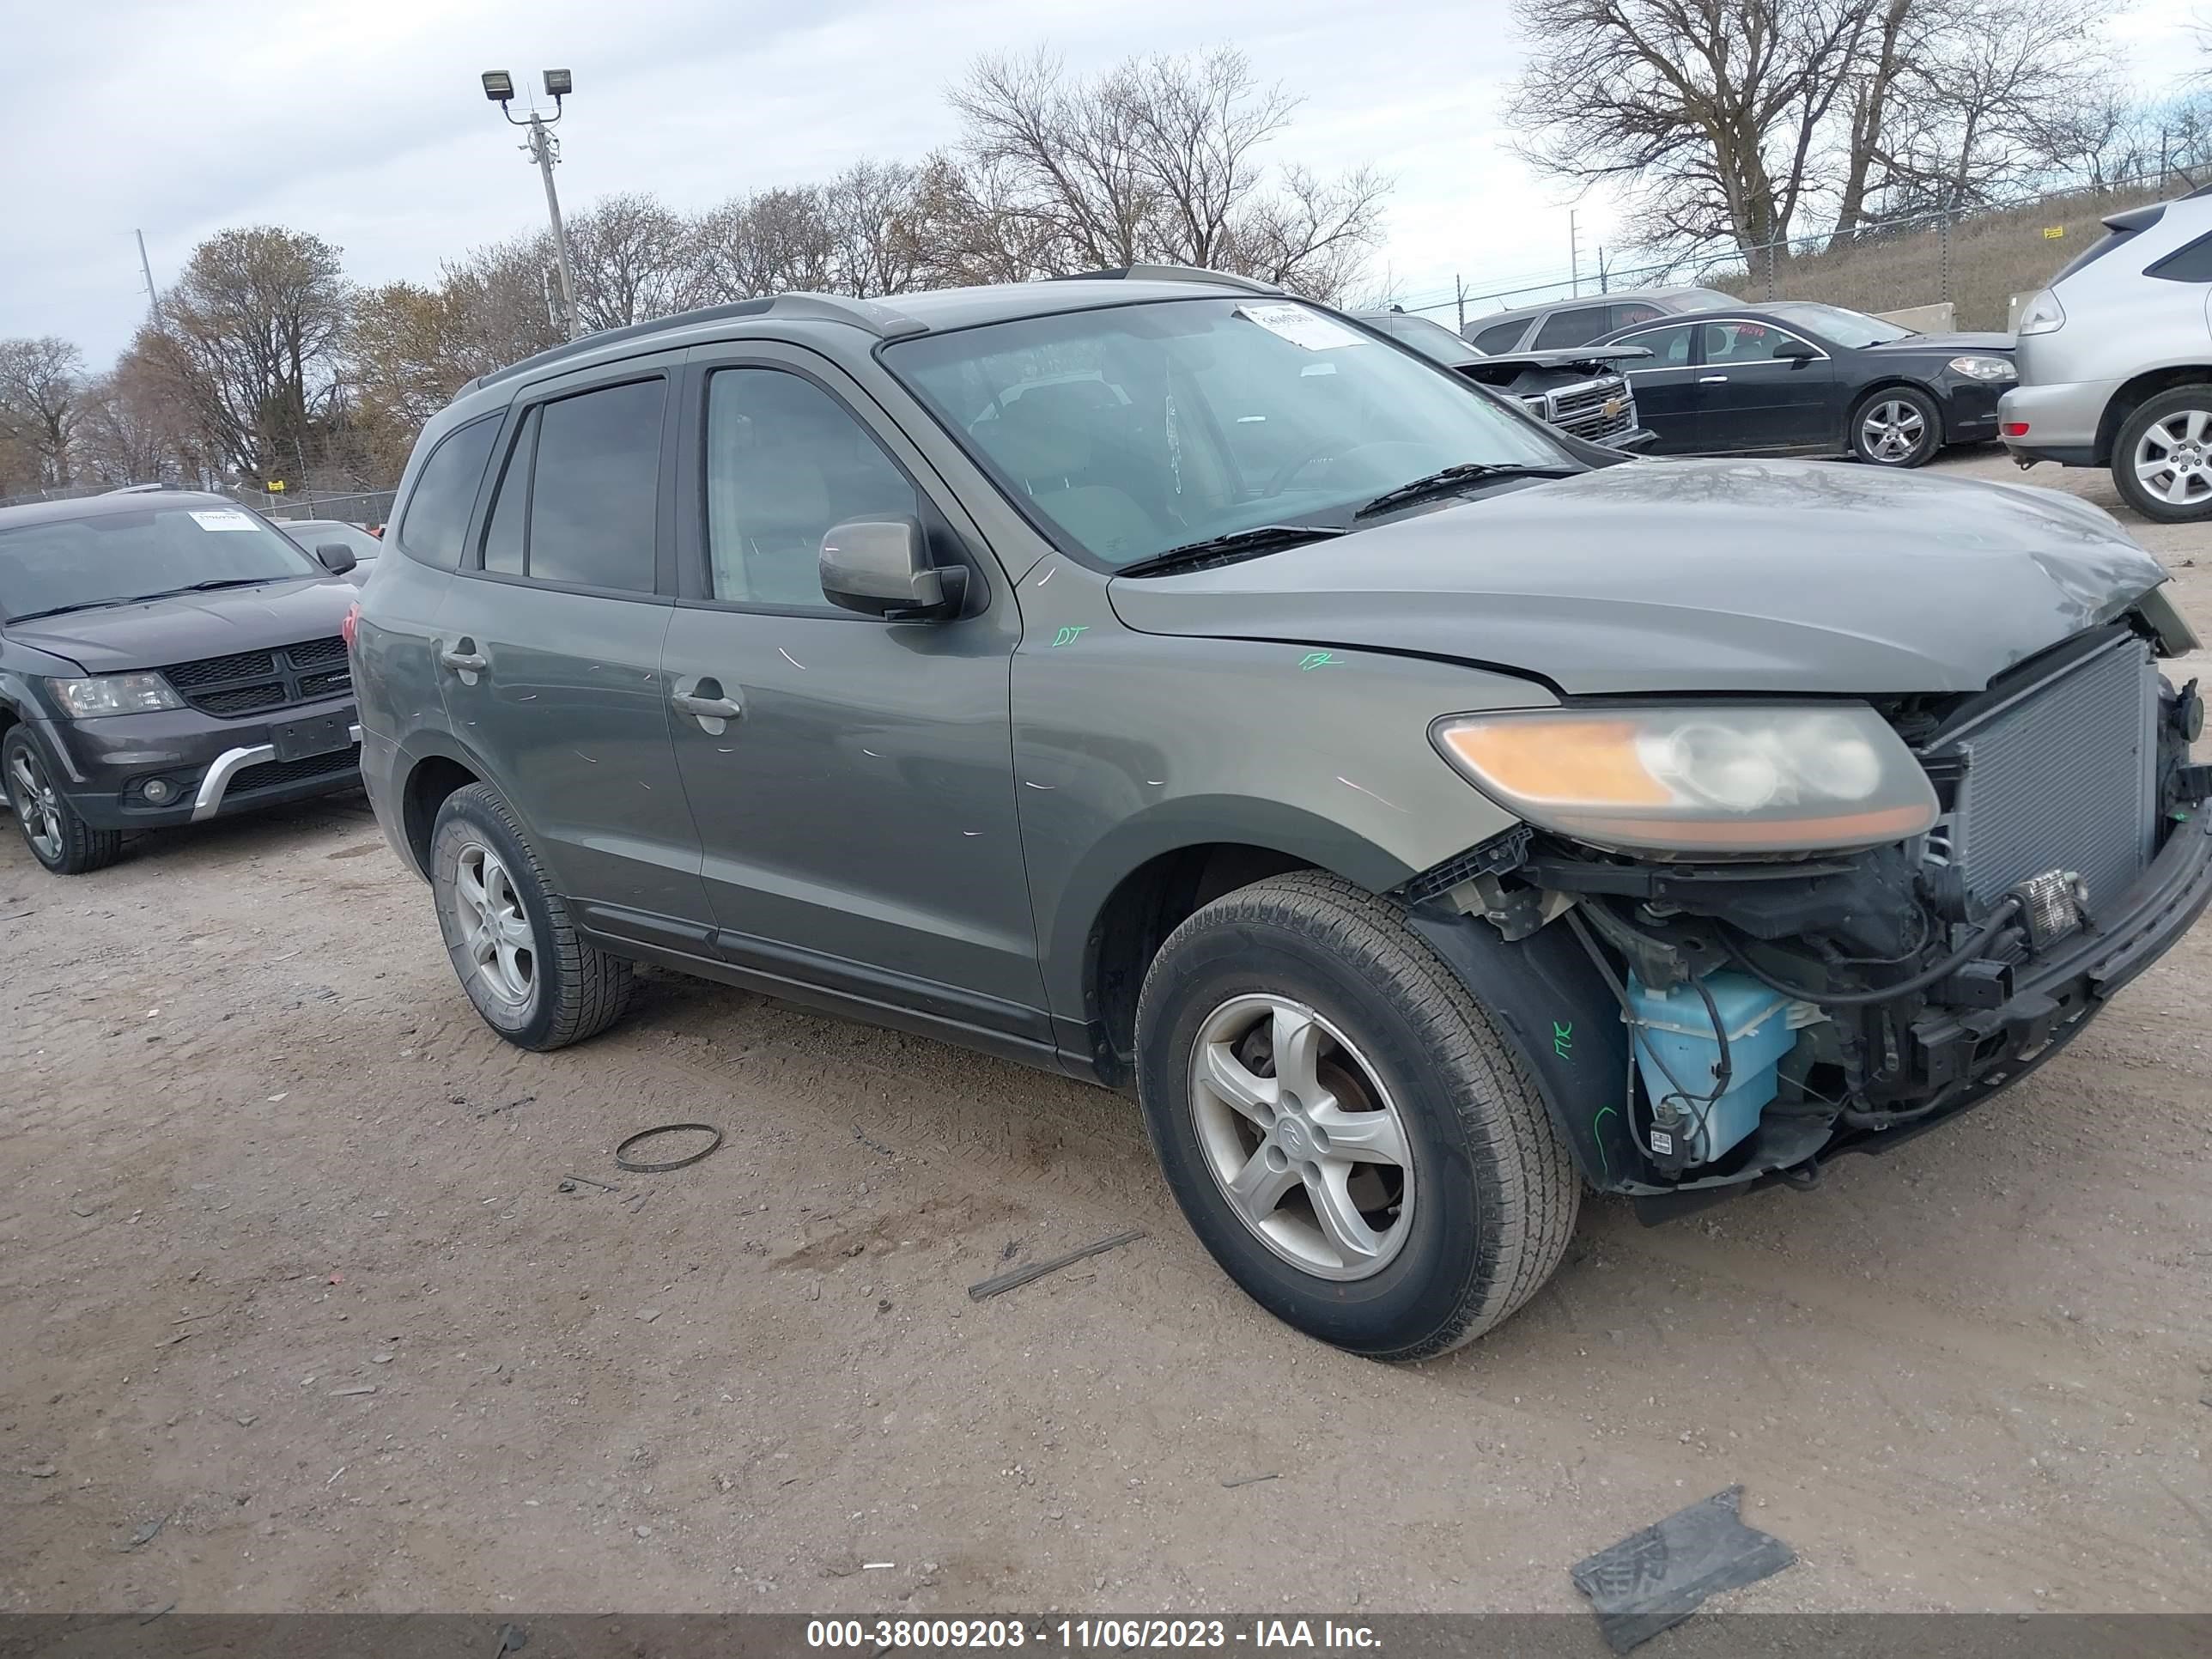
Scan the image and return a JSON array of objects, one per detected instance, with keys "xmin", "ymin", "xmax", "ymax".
[{"xmin": 0, "ymin": 456, "xmax": 2212, "ymax": 1613}]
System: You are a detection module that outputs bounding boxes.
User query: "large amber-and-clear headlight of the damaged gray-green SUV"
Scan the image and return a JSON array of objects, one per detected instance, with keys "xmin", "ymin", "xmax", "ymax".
[{"xmin": 1429, "ymin": 703, "xmax": 1938, "ymax": 852}]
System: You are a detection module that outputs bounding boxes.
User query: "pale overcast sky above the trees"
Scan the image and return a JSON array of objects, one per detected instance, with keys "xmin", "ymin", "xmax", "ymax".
[{"xmin": 0, "ymin": 0, "xmax": 2205, "ymax": 368}]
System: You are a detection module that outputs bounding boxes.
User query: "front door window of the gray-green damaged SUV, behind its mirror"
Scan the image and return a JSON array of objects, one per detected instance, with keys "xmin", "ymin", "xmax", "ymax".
[{"xmin": 706, "ymin": 369, "xmax": 921, "ymax": 615}]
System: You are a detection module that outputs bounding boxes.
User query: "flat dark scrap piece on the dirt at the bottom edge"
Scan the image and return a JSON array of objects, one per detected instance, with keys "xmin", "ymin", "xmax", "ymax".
[{"xmin": 1568, "ymin": 1486, "xmax": 1796, "ymax": 1652}]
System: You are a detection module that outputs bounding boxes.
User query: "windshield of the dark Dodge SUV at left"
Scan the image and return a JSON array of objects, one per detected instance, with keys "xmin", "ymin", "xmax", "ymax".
[{"xmin": 0, "ymin": 507, "xmax": 325, "ymax": 617}]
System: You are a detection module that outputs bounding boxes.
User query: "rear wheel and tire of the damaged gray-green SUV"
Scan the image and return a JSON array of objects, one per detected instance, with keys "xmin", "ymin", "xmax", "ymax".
[{"xmin": 429, "ymin": 783, "xmax": 635, "ymax": 1051}]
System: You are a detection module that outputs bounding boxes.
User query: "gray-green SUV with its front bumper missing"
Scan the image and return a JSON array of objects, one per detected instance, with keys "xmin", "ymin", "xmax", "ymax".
[{"xmin": 354, "ymin": 272, "xmax": 2212, "ymax": 1358}]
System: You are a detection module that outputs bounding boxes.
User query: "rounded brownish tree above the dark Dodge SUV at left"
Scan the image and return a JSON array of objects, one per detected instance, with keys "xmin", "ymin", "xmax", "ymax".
[{"xmin": 133, "ymin": 226, "xmax": 352, "ymax": 473}]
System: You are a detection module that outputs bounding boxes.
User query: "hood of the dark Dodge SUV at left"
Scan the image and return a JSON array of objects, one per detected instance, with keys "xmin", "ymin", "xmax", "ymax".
[{"xmin": 7, "ymin": 575, "xmax": 361, "ymax": 675}]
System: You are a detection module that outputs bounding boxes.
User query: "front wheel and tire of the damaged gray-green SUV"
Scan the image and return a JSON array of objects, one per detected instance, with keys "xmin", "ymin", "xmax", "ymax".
[{"xmin": 1137, "ymin": 872, "xmax": 1582, "ymax": 1360}]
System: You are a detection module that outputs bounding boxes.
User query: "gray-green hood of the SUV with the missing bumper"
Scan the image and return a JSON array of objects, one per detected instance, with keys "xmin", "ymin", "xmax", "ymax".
[{"xmin": 1109, "ymin": 460, "xmax": 2166, "ymax": 696}]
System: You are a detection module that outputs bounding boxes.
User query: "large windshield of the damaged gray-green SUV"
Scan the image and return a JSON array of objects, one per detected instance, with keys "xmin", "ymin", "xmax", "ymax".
[{"xmin": 883, "ymin": 299, "xmax": 1577, "ymax": 566}]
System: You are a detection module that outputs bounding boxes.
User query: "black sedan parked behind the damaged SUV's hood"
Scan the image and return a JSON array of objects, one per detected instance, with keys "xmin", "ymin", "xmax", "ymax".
[{"xmin": 1604, "ymin": 301, "xmax": 2017, "ymax": 467}]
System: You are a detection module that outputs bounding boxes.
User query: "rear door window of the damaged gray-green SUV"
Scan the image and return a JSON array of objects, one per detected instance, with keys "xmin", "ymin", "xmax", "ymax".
[{"xmin": 484, "ymin": 378, "xmax": 668, "ymax": 592}]
